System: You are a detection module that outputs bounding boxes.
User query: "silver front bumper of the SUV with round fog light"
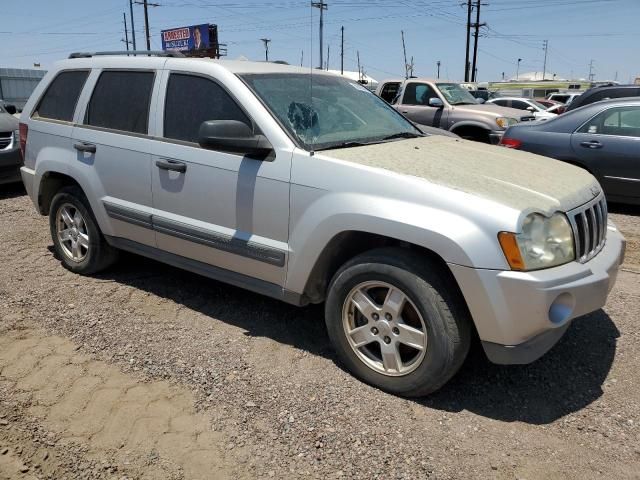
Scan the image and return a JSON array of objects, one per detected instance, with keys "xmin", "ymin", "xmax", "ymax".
[{"xmin": 449, "ymin": 225, "xmax": 626, "ymax": 364}]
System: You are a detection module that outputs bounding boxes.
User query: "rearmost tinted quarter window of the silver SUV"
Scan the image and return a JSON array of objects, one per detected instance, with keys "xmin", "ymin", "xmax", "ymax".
[{"xmin": 34, "ymin": 70, "xmax": 89, "ymax": 122}]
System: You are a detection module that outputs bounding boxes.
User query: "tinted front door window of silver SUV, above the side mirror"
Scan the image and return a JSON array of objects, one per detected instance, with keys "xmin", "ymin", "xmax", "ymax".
[{"xmin": 164, "ymin": 73, "xmax": 252, "ymax": 143}]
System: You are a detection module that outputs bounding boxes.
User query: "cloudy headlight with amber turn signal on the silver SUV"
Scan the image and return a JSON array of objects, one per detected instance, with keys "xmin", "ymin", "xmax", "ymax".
[{"xmin": 498, "ymin": 213, "xmax": 575, "ymax": 270}]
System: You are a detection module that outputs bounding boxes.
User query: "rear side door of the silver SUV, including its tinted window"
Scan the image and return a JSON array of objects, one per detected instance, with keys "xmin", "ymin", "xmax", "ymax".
[{"xmin": 73, "ymin": 69, "xmax": 156, "ymax": 246}]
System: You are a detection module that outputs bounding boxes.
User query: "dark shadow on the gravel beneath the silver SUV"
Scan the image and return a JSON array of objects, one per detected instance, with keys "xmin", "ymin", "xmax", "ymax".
[{"xmin": 80, "ymin": 253, "xmax": 619, "ymax": 424}]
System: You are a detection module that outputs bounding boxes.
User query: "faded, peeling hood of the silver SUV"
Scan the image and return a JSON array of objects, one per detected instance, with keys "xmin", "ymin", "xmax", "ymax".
[{"xmin": 322, "ymin": 136, "xmax": 601, "ymax": 214}]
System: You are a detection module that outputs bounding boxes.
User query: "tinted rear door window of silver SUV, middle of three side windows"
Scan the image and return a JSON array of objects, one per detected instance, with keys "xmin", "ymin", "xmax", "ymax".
[{"xmin": 85, "ymin": 71, "xmax": 155, "ymax": 134}]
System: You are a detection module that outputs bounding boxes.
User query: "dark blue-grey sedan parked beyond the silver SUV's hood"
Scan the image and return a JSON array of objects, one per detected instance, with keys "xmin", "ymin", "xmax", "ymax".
[{"xmin": 502, "ymin": 98, "xmax": 640, "ymax": 204}]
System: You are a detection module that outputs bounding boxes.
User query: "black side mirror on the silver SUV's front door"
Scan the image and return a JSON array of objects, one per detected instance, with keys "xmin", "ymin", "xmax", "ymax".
[{"xmin": 198, "ymin": 120, "xmax": 273, "ymax": 159}]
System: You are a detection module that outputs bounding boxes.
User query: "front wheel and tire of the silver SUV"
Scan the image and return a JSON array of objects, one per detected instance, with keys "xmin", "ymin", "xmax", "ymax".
[{"xmin": 325, "ymin": 248, "xmax": 471, "ymax": 397}]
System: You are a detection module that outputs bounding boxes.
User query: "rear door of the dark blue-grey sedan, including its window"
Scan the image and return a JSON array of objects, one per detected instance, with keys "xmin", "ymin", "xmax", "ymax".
[{"xmin": 571, "ymin": 106, "xmax": 640, "ymax": 199}]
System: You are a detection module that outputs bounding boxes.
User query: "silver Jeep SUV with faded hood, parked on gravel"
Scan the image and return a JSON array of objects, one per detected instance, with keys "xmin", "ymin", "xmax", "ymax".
[{"xmin": 21, "ymin": 54, "xmax": 625, "ymax": 396}]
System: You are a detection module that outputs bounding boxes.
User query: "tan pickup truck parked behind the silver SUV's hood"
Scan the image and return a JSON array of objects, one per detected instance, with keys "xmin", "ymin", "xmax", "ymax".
[{"xmin": 376, "ymin": 78, "xmax": 535, "ymax": 144}]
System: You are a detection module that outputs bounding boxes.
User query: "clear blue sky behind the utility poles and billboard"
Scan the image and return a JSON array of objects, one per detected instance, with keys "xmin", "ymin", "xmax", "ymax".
[{"xmin": 0, "ymin": 0, "xmax": 640, "ymax": 82}]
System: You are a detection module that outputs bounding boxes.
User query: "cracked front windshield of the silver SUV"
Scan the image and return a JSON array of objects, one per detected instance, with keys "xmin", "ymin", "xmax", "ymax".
[{"xmin": 242, "ymin": 73, "xmax": 422, "ymax": 150}]
